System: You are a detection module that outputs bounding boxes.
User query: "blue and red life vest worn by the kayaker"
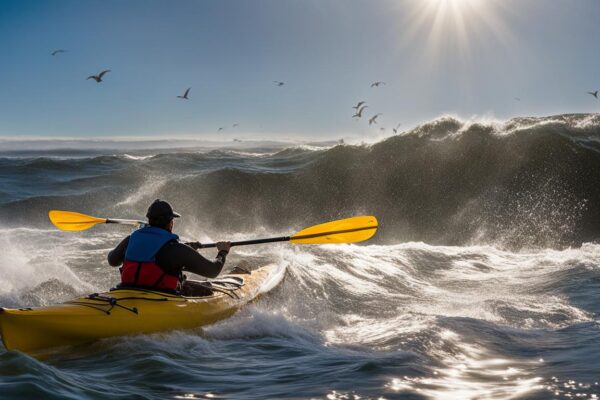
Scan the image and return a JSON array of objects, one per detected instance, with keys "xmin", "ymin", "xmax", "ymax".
[{"xmin": 120, "ymin": 226, "xmax": 180, "ymax": 291}]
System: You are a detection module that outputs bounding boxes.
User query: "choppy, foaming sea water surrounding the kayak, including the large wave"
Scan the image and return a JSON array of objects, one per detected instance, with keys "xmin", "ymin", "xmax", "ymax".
[{"xmin": 0, "ymin": 116, "xmax": 600, "ymax": 399}]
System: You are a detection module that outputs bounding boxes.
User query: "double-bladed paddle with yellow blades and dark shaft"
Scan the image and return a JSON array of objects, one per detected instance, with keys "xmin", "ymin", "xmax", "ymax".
[{"xmin": 48, "ymin": 210, "xmax": 378, "ymax": 248}]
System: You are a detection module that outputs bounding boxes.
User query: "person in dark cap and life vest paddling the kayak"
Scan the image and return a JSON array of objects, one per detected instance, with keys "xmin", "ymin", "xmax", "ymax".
[{"xmin": 108, "ymin": 199, "xmax": 231, "ymax": 296}]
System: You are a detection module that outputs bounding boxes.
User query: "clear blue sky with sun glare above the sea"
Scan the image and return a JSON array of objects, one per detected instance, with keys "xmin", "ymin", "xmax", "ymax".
[{"xmin": 0, "ymin": 0, "xmax": 600, "ymax": 139}]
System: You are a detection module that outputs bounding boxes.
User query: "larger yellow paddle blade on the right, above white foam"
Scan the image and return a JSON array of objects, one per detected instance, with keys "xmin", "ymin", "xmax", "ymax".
[{"xmin": 290, "ymin": 215, "xmax": 377, "ymax": 244}]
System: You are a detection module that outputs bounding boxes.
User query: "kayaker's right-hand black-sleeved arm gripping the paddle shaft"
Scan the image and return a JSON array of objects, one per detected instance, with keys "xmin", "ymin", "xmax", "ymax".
[{"xmin": 156, "ymin": 242, "xmax": 227, "ymax": 278}]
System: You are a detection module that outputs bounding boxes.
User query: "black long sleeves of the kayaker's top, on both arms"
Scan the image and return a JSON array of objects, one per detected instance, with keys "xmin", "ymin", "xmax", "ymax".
[{"xmin": 108, "ymin": 236, "xmax": 227, "ymax": 278}]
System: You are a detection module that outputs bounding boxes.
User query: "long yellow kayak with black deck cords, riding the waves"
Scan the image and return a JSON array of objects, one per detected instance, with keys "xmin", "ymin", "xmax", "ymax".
[{"xmin": 0, "ymin": 265, "xmax": 285, "ymax": 352}]
